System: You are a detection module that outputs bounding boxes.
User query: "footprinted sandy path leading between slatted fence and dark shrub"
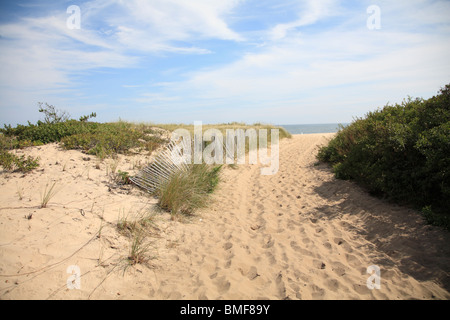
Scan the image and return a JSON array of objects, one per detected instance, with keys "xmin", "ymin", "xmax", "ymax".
[{"xmin": 149, "ymin": 135, "xmax": 450, "ymax": 299}]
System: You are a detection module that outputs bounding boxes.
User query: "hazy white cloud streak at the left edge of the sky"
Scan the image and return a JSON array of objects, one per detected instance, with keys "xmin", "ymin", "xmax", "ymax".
[{"xmin": 0, "ymin": 17, "xmax": 136, "ymax": 90}]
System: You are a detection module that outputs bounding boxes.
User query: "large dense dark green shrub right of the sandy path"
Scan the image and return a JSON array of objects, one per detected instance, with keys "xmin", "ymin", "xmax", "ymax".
[{"xmin": 318, "ymin": 85, "xmax": 450, "ymax": 226}]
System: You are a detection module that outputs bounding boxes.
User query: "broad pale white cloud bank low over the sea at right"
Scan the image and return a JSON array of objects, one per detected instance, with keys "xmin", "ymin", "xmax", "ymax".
[{"xmin": 133, "ymin": 1, "xmax": 450, "ymax": 122}]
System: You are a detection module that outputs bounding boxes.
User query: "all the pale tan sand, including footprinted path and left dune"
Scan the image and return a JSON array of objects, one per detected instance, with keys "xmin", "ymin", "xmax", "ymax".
[{"xmin": 0, "ymin": 134, "xmax": 450, "ymax": 300}]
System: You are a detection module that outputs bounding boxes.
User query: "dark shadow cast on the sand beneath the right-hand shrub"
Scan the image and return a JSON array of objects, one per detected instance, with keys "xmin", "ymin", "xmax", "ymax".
[{"xmin": 311, "ymin": 165, "xmax": 450, "ymax": 292}]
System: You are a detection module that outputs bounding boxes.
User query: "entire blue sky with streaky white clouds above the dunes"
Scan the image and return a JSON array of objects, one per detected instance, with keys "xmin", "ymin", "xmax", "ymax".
[{"xmin": 0, "ymin": 0, "xmax": 450, "ymax": 126}]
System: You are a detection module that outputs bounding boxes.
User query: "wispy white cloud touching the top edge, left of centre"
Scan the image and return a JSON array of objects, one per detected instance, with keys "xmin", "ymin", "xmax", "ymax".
[{"xmin": 97, "ymin": 0, "xmax": 244, "ymax": 54}]
